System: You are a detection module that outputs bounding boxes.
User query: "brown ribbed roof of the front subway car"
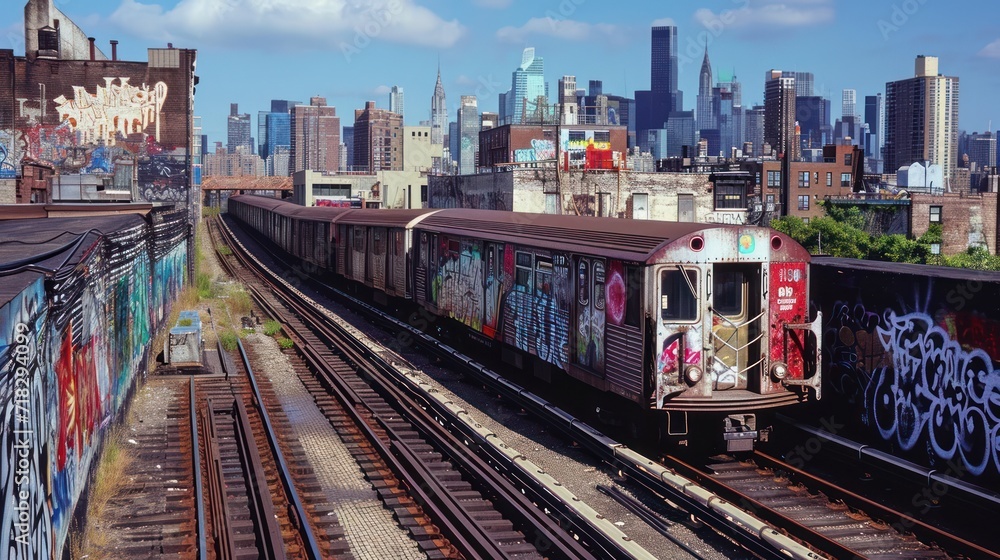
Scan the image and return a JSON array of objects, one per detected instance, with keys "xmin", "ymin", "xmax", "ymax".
[{"xmin": 417, "ymin": 209, "xmax": 730, "ymax": 262}]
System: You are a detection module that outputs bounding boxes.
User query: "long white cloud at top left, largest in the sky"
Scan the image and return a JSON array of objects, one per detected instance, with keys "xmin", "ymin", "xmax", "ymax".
[{"xmin": 111, "ymin": 0, "xmax": 465, "ymax": 50}]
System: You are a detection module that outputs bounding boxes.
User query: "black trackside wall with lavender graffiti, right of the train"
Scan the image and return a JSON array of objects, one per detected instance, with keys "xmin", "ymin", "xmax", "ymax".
[{"xmin": 811, "ymin": 261, "xmax": 1000, "ymax": 479}]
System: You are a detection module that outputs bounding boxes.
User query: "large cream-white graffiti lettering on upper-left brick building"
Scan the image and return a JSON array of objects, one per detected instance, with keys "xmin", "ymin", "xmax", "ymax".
[{"xmin": 53, "ymin": 77, "xmax": 167, "ymax": 146}]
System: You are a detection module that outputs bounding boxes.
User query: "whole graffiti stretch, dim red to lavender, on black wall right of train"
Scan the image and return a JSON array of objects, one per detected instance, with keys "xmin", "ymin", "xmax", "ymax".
[{"xmin": 824, "ymin": 303, "xmax": 1000, "ymax": 476}]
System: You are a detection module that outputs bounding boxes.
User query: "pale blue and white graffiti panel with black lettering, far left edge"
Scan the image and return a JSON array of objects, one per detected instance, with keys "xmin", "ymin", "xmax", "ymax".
[{"xmin": 0, "ymin": 279, "xmax": 52, "ymax": 558}]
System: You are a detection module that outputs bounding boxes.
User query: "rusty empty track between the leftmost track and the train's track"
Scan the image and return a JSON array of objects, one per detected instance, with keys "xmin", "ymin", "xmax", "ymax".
[{"xmin": 208, "ymin": 213, "xmax": 608, "ymax": 558}]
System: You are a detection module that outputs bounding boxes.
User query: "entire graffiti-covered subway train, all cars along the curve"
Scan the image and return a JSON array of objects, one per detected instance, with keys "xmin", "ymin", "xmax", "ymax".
[{"xmin": 228, "ymin": 195, "xmax": 821, "ymax": 451}]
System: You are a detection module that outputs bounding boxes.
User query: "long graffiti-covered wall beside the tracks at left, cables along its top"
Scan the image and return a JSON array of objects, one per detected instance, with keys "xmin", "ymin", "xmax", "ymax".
[{"xmin": 0, "ymin": 212, "xmax": 187, "ymax": 558}]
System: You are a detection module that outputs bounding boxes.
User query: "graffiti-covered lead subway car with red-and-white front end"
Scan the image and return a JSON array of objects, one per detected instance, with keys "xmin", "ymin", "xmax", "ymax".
[{"xmin": 413, "ymin": 210, "xmax": 821, "ymax": 450}]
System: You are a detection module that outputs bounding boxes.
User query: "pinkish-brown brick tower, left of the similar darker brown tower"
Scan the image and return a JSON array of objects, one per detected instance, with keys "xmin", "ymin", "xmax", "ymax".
[{"xmin": 290, "ymin": 97, "xmax": 340, "ymax": 173}]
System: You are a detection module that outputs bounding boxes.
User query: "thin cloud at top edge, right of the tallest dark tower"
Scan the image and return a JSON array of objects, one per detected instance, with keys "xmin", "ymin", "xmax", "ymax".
[{"xmin": 694, "ymin": 0, "xmax": 836, "ymax": 29}]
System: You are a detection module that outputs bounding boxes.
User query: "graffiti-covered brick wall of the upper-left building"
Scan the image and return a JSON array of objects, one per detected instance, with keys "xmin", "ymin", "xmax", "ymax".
[{"xmin": 0, "ymin": 49, "xmax": 195, "ymax": 202}]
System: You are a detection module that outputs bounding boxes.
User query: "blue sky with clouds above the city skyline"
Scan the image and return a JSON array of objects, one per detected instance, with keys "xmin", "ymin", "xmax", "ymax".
[{"xmin": 0, "ymin": 0, "xmax": 1000, "ymax": 142}]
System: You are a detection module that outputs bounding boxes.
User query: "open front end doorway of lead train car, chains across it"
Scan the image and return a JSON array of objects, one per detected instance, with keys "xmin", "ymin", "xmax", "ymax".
[{"xmin": 709, "ymin": 263, "xmax": 764, "ymax": 390}]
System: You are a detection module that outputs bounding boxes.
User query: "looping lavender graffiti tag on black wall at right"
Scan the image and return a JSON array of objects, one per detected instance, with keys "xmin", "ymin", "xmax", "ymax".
[{"xmin": 868, "ymin": 311, "xmax": 1000, "ymax": 475}]
